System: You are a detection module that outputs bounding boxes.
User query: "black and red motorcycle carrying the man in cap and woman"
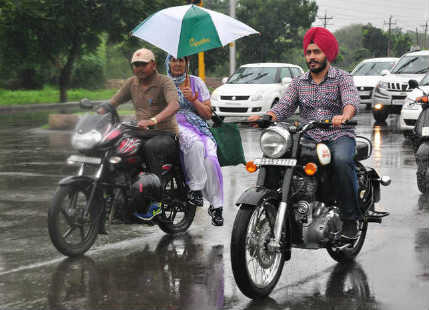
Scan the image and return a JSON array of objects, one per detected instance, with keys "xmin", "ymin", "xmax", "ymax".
[{"xmin": 48, "ymin": 100, "xmax": 196, "ymax": 257}]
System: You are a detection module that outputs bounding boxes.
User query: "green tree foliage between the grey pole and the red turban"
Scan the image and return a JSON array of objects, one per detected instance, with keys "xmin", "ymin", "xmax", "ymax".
[{"xmin": 237, "ymin": 0, "xmax": 317, "ymax": 63}]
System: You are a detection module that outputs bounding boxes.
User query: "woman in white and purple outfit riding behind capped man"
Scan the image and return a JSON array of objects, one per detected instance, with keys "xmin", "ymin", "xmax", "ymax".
[{"xmin": 165, "ymin": 55, "xmax": 223, "ymax": 226}]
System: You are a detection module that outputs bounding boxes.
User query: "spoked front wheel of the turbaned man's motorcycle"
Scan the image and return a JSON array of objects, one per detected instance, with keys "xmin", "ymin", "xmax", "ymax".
[{"xmin": 230, "ymin": 203, "xmax": 285, "ymax": 299}]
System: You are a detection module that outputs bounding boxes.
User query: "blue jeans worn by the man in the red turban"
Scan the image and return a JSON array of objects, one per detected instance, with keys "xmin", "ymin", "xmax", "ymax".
[{"xmin": 325, "ymin": 136, "xmax": 362, "ymax": 220}]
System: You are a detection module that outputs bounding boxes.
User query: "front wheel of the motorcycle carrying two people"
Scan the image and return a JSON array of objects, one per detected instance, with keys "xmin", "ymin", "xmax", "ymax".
[{"xmin": 48, "ymin": 185, "xmax": 100, "ymax": 257}]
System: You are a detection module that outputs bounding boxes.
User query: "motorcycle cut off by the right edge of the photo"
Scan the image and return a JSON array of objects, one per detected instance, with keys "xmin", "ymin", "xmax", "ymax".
[{"xmin": 408, "ymin": 80, "xmax": 429, "ymax": 194}]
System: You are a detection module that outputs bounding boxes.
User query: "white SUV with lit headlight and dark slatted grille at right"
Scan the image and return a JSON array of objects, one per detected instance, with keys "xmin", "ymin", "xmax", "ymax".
[{"xmin": 372, "ymin": 50, "xmax": 429, "ymax": 122}]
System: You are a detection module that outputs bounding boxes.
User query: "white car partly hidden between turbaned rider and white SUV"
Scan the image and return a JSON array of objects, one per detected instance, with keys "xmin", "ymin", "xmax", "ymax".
[{"xmin": 351, "ymin": 57, "xmax": 399, "ymax": 109}]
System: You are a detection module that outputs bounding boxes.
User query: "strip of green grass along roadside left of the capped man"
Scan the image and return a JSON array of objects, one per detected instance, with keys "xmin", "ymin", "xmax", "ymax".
[{"xmin": 0, "ymin": 86, "xmax": 117, "ymax": 105}]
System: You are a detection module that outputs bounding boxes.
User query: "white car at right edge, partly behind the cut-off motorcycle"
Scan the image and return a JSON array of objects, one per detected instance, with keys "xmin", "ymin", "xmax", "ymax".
[{"xmin": 399, "ymin": 73, "xmax": 429, "ymax": 136}]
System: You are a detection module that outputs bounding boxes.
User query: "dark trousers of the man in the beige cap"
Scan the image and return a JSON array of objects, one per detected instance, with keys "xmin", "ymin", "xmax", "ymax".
[{"xmin": 143, "ymin": 134, "xmax": 179, "ymax": 183}]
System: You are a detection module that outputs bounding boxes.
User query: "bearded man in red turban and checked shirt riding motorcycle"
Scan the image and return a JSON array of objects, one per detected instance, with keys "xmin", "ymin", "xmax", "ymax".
[{"xmin": 248, "ymin": 27, "xmax": 362, "ymax": 240}]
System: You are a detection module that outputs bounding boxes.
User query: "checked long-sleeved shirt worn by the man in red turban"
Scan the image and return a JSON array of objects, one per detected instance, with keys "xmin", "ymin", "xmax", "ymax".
[{"xmin": 271, "ymin": 66, "xmax": 360, "ymax": 142}]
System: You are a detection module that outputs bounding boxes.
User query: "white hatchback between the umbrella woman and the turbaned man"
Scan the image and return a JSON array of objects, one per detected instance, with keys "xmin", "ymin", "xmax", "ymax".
[{"xmin": 211, "ymin": 63, "xmax": 304, "ymax": 117}]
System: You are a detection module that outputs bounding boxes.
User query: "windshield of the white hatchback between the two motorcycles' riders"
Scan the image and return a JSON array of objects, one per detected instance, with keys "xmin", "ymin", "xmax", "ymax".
[{"xmin": 226, "ymin": 67, "xmax": 280, "ymax": 84}]
